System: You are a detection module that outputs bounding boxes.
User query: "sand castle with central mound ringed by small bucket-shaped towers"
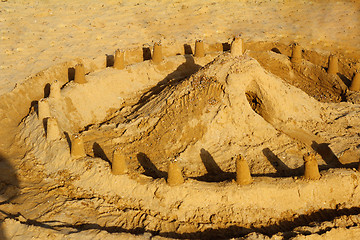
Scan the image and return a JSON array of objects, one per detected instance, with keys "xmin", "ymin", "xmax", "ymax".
[{"xmin": 4, "ymin": 39, "xmax": 357, "ymax": 239}]
